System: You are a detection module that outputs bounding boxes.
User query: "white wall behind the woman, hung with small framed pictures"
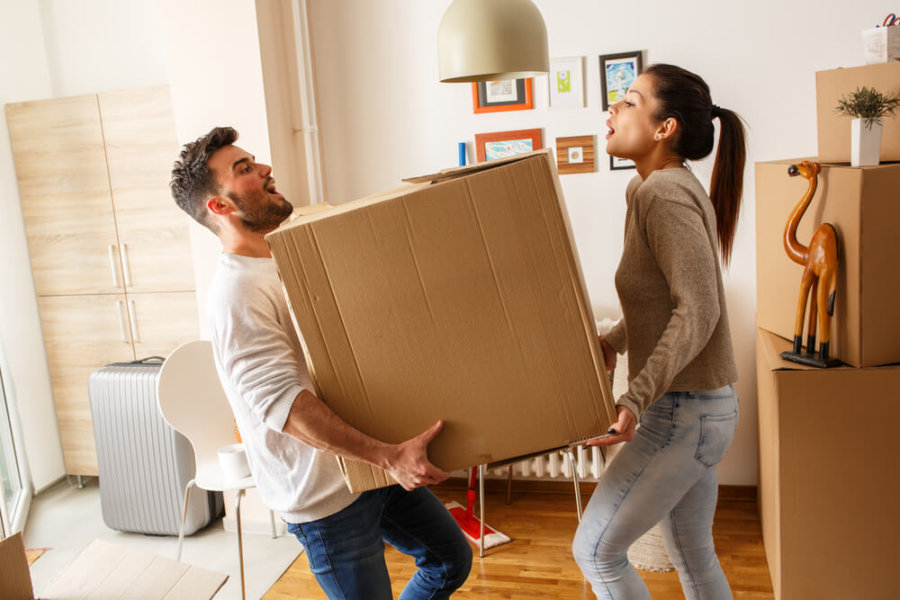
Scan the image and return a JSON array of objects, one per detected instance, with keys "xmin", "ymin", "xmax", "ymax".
[{"xmin": 310, "ymin": 0, "xmax": 891, "ymax": 485}]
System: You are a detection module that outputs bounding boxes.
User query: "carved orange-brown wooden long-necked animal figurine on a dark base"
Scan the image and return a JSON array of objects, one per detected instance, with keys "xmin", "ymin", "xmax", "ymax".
[{"xmin": 781, "ymin": 160, "xmax": 841, "ymax": 367}]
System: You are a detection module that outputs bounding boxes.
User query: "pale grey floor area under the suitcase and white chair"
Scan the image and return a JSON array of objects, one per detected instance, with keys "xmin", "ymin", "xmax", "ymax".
[{"xmin": 24, "ymin": 478, "xmax": 302, "ymax": 600}]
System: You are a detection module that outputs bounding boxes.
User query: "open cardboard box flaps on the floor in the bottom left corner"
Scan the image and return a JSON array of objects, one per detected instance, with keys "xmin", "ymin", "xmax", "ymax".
[{"xmin": 0, "ymin": 533, "xmax": 228, "ymax": 600}]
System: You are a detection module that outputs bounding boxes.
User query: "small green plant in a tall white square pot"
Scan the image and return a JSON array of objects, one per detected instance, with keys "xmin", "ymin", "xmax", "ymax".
[{"xmin": 835, "ymin": 87, "xmax": 900, "ymax": 167}]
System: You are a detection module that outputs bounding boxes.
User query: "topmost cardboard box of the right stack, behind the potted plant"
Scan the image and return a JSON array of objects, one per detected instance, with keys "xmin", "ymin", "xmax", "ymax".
[{"xmin": 816, "ymin": 61, "xmax": 900, "ymax": 163}]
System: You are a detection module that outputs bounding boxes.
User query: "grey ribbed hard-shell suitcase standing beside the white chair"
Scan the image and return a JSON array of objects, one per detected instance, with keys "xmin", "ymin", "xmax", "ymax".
[{"xmin": 88, "ymin": 356, "xmax": 224, "ymax": 535}]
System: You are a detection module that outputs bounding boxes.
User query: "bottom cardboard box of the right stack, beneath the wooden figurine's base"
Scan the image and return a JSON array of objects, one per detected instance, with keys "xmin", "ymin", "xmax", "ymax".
[{"xmin": 756, "ymin": 329, "xmax": 900, "ymax": 600}]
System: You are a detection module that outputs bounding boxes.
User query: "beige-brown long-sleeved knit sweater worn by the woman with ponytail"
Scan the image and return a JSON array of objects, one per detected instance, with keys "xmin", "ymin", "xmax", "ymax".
[{"xmin": 606, "ymin": 168, "xmax": 737, "ymax": 417}]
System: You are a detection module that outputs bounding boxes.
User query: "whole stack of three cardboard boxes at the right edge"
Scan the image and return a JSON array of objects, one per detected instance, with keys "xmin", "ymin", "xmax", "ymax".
[{"xmin": 756, "ymin": 63, "xmax": 900, "ymax": 600}]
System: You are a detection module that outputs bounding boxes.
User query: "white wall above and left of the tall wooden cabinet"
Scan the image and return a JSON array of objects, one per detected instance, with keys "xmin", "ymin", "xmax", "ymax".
[{"xmin": 0, "ymin": 0, "xmax": 167, "ymax": 490}]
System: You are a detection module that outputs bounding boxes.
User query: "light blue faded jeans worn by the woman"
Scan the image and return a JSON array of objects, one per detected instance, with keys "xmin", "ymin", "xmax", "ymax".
[{"xmin": 572, "ymin": 385, "xmax": 738, "ymax": 600}]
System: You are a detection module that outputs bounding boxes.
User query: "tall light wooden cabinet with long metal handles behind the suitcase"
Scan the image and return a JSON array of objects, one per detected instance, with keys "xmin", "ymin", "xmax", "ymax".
[{"xmin": 6, "ymin": 87, "xmax": 198, "ymax": 475}]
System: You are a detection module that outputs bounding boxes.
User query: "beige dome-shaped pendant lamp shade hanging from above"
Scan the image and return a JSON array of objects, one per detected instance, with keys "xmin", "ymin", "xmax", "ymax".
[{"xmin": 438, "ymin": 0, "xmax": 550, "ymax": 82}]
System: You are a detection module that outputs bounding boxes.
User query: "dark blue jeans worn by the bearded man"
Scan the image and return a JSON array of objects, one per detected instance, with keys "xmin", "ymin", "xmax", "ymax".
[{"xmin": 288, "ymin": 485, "xmax": 472, "ymax": 600}]
